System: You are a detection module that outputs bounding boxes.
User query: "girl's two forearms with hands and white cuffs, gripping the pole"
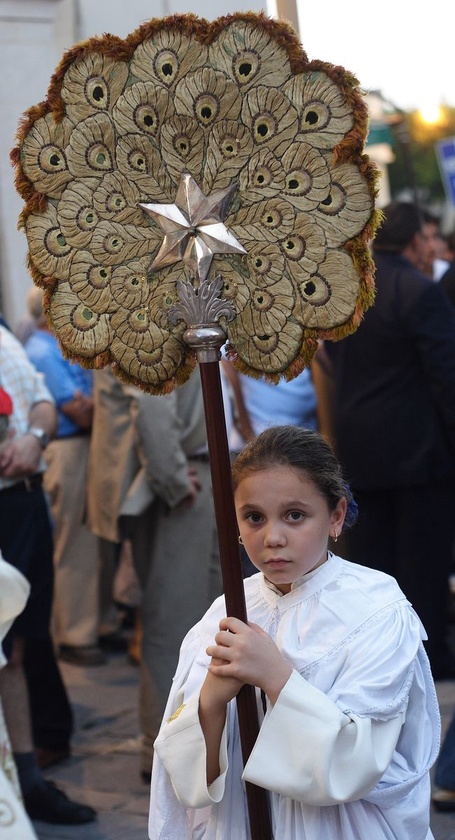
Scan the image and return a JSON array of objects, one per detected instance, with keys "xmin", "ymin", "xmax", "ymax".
[{"xmin": 155, "ymin": 618, "xmax": 405, "ymax": 807}]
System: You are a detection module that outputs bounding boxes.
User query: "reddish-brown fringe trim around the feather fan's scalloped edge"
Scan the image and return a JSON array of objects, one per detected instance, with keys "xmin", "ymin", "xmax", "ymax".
[{"xmin": 10, "ymin": 12, "xmax": 382, "ymax": 395}]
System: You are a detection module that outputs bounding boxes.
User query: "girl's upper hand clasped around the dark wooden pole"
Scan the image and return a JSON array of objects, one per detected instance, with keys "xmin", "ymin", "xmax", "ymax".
[{"xmin": 207, "ymin": 617, "xmax": 292, "ymax": 703}]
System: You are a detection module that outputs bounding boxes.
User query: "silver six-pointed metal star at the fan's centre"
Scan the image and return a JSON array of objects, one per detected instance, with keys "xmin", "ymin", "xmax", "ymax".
[{"xmin": 139, "ymin": 172, "xmax": 246, "ymax": 281}]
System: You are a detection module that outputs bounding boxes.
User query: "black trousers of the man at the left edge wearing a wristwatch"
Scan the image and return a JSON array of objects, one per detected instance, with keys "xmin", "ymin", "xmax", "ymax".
[{"xmin": 0, "ymin": 487, "xmax": 73, "ymax": 750}]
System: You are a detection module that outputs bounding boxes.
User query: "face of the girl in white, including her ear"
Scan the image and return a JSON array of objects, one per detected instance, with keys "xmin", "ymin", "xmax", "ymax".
[{"xmin": 234, "ymin": 466, "xmax": 346, "ymax": 594}]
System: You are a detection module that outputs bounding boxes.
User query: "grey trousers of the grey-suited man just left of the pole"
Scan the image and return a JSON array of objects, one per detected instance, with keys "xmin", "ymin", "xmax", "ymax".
[{"xmin": 133, "ymin": 463, "xmax": 222, "ymax": 771}]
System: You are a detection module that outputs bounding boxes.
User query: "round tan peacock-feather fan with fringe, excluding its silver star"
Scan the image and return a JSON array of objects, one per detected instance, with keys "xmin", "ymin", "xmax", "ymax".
[{"xmin": 11, "ymin": 12, "xmax": 379, "ymax": 394}]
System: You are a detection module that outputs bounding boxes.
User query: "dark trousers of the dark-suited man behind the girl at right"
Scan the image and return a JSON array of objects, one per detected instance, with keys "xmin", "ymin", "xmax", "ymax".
[{"xmin": 346, "ymin": 484, "xmax": 455, "ymax": 677}]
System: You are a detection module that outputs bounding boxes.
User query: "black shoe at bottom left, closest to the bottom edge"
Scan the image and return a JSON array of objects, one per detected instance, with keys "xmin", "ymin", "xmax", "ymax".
[{"xmin": 24, "ymin": 779, "xmax": 96, "ymax": 825}]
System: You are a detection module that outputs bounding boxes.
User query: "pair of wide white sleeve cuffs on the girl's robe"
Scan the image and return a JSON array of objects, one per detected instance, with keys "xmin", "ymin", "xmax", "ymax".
[{"xmin": 155, "ymin": 671, "xmax": 404, "ymax": 808}]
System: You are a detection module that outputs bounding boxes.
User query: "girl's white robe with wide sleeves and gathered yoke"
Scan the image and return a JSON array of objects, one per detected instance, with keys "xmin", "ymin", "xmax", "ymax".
[{"xmin": 149, "ymin": 555, "xmax": 440, "ymax": 840}]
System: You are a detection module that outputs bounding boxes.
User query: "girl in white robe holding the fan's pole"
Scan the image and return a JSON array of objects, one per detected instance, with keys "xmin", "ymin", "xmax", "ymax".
[{"xmin": 149, "ymin": 426, "xmax": 439, "ymax": 840}]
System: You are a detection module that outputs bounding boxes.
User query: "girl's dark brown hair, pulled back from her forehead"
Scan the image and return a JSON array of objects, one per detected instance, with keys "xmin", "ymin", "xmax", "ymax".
[{"xmin": 232, "ymin": 426, "xmax": 357, "ymax": 528}]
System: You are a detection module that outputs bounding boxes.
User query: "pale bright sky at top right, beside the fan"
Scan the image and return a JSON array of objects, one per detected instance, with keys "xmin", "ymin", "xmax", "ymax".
[{"xmin": 270, "ymin": 0, "xmax": 455, "ymax": 115}]
